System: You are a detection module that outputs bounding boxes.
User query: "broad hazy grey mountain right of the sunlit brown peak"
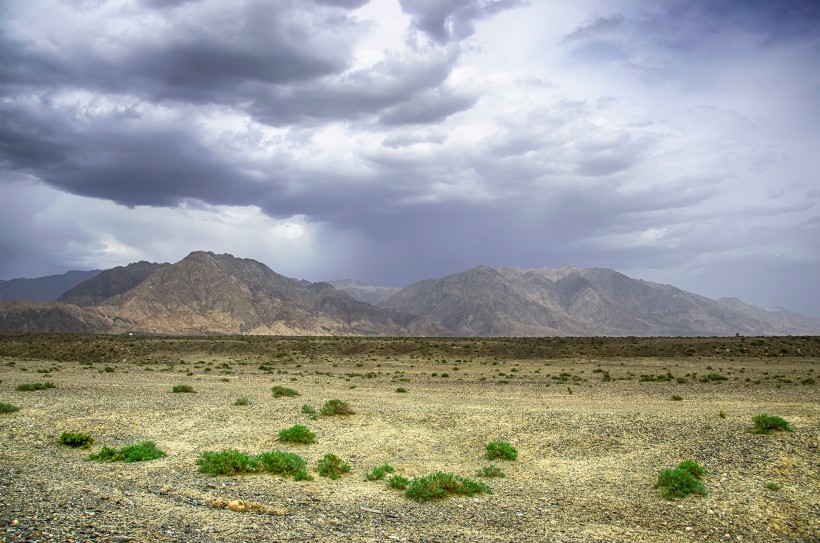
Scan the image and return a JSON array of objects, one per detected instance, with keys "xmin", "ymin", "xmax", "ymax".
[{"xmin": 381, "ymin": 266, "xmax": 820, "ymax": 336}]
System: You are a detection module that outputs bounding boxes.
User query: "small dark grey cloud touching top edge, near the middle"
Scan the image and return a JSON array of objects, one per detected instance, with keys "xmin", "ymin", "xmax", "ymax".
[{"xmin": 400, "ymin": 0, "xmax": 526, "ymax": 43}]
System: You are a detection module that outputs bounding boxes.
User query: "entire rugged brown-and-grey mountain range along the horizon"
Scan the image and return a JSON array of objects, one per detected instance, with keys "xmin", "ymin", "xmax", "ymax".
[{"xmin": 0, "ymin": 251, "xmax": 820, "ymax": 336}]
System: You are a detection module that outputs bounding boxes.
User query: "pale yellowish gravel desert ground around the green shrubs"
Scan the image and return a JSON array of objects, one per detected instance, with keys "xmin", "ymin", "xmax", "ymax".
[{"xmin": 0, "ymin": 353, "xmax": 820, "ymax": 543}]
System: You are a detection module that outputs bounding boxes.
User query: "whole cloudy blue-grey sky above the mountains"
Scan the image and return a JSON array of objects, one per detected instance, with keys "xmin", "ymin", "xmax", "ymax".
[{"xmin": 0, "ymin": 0, "xmax": 820, "ymax": 317}]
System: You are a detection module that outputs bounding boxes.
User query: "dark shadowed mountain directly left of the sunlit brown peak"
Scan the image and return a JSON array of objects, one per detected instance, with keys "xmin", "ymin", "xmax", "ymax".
[{"xmin": 57, "ymin": 260, "xmax": 170, "ymax": 307}]
